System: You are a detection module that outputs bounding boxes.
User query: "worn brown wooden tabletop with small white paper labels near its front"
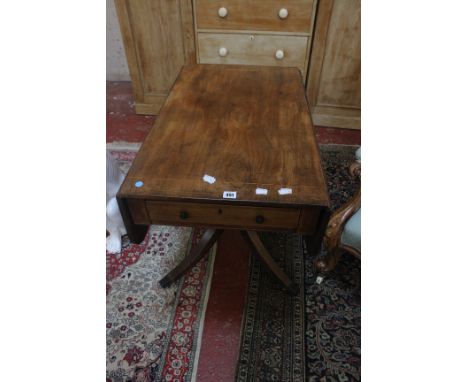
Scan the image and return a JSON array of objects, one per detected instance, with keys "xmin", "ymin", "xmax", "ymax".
[{"xmin": 119, "ymin": 65, "xmax": 329, "ymax": 206}]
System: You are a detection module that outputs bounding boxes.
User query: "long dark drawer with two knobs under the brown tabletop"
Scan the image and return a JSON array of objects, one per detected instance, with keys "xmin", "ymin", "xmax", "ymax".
[{"xmin": 146, "ymin": 201, "xmax": 300, "ymax": 230}]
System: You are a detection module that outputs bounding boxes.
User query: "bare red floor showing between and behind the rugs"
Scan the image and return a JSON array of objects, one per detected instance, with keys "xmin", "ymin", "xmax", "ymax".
[{"xmin": 106, "ymin": 82, "xmax": 361, "ymax": 382}]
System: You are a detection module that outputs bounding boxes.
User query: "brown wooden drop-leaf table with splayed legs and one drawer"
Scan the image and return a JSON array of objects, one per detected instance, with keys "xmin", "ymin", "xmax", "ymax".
[{"xmin": 117, "ymin": 65, "xmax": 329, "ymax": 294}]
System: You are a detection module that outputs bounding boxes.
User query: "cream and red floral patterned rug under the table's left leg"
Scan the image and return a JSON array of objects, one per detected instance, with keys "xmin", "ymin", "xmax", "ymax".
[{"xmin": 106, "ymin": 151, "xmax": 215, "ymax": 382}]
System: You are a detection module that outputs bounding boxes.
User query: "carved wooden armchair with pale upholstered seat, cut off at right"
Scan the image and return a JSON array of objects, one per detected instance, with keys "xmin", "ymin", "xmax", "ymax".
[{"xmin": 315, "ymin": 148, "xmax": 361, "ymax": 272}]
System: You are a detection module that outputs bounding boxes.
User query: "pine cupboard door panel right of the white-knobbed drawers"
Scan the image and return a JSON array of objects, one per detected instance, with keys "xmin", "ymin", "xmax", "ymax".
[{"xmin": 307, "ymin": 0, "xmax": 361, "ymax": 129}]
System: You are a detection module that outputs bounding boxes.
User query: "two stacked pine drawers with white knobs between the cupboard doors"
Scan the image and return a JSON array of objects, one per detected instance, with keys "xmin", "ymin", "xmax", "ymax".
[{"xmin": 193, "ymin": 0, "xmax": 315, "ymax": 82}]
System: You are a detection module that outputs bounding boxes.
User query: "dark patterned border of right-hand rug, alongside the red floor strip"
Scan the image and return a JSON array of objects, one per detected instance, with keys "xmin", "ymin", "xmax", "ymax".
[{"xmin": 236, "ymin": 233, "xmax": 305, "ymax": 382}]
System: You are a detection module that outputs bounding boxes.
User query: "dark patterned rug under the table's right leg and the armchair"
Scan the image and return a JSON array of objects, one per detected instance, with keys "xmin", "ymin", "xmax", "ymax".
[{"xmin": 237, "ymin": 145, "xmax": 361, "ymax": 382}]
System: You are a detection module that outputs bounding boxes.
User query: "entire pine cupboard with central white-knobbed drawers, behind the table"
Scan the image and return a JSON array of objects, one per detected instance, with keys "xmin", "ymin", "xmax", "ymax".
[{"xmin": 115, "ymin": 0, "xmax": 360, "ymax": 129}]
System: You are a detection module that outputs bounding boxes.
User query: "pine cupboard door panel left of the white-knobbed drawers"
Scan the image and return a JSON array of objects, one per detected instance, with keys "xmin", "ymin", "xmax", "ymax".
[{"xmin": 115, "ymin": 0, "xmax": 196, "ymax": 114}]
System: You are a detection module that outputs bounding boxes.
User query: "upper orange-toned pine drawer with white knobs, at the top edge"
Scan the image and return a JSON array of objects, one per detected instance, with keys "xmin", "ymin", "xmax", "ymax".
[{"xmin": 196, "ymin": 0, "xmax": 314, "ymax": 33}]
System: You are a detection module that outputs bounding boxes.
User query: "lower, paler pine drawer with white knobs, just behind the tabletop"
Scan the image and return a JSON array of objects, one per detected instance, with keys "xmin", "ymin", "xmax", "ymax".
[{"xmin": 198, "ymin": 33, "xmax": 308, "ymax": 74}]
